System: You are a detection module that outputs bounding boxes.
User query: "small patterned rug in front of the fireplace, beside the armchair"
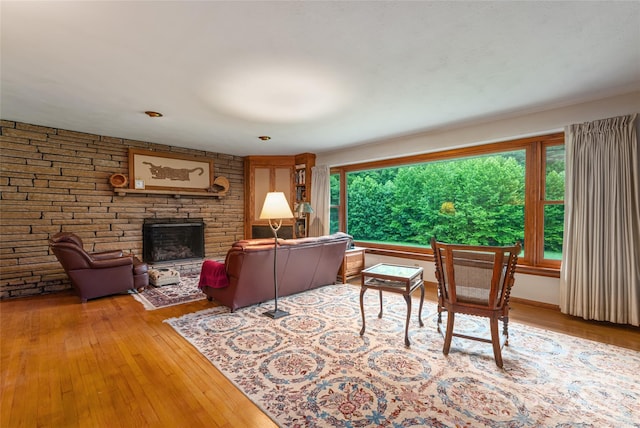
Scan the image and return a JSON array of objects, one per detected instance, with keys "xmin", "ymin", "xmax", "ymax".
[{"xmin": 132, "ymin": 275, "xmax": 207, "ymax": 310}]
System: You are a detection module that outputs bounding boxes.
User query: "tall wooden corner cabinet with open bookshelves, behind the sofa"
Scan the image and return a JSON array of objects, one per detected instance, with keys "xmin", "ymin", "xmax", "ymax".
[{"xmin": 244, "ymin": 153, "xmax": 315, "ymax": 239}]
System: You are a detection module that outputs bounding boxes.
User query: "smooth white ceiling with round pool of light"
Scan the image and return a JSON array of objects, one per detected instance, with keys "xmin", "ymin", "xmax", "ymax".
[{"xmin": 0, "ymin": 0, "xmax": 640, "ymax": 156}]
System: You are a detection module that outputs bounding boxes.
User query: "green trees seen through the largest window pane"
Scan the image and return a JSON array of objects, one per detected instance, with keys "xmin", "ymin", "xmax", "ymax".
[{"xmin": 347, "ymin": 152, "xmax": 536, "ymax": 245}]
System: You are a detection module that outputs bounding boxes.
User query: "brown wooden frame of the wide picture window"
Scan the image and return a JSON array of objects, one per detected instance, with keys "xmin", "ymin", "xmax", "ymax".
[{"xmin": 330, "ymin": 132, "xmax": 564, "ymax": 277}]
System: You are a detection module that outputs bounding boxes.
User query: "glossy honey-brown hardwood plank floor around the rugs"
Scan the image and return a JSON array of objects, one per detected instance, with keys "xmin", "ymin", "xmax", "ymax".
[{"xmin": 0, "ymin": 282, "xmax": 640, "ymax": 427}]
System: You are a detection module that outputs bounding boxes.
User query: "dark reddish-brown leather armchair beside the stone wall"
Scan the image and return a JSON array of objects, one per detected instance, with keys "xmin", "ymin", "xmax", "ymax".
[{"xmin": 49, "ymin": 232, "xmax": 149, "ymax": 303}]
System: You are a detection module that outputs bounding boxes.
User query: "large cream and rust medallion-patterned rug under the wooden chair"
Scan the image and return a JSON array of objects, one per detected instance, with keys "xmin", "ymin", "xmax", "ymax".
[{"xmin": 165, "ymin": 285, "xmax": 640, "ymax": 427}]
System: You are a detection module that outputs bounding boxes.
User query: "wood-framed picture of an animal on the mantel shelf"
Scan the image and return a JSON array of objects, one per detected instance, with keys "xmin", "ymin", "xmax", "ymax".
[{"xmin": 129, "ymin": 149, "xmax": 214, "ymax": 192}]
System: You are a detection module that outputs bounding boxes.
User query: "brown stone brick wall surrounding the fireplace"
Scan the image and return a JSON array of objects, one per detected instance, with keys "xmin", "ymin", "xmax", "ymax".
[{"xmin": 0, "ymin": 120, "xmax": 244, "ymax": 299}]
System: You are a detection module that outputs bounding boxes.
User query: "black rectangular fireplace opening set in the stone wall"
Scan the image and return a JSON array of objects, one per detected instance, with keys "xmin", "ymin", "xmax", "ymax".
[{"xmin": 142, "ymin": 218, "xmax": 204, "ymax": 264}]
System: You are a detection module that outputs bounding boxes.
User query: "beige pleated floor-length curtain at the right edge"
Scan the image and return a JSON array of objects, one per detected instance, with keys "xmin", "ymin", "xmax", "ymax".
[{"xmin": 560, "ymin": 115, "xmax": 640, "ymax": 326}]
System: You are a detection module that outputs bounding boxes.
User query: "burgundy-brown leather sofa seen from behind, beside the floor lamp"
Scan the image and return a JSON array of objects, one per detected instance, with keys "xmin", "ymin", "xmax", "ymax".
[{"xmin": 201, "ymin": 232, "xmax": 352, "ymax": 311}]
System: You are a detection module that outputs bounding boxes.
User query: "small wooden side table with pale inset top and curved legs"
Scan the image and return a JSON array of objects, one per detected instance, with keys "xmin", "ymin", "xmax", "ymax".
[{"xmin": 360, "ymin": 263, "xmax": 424, "ymax": 346}]
